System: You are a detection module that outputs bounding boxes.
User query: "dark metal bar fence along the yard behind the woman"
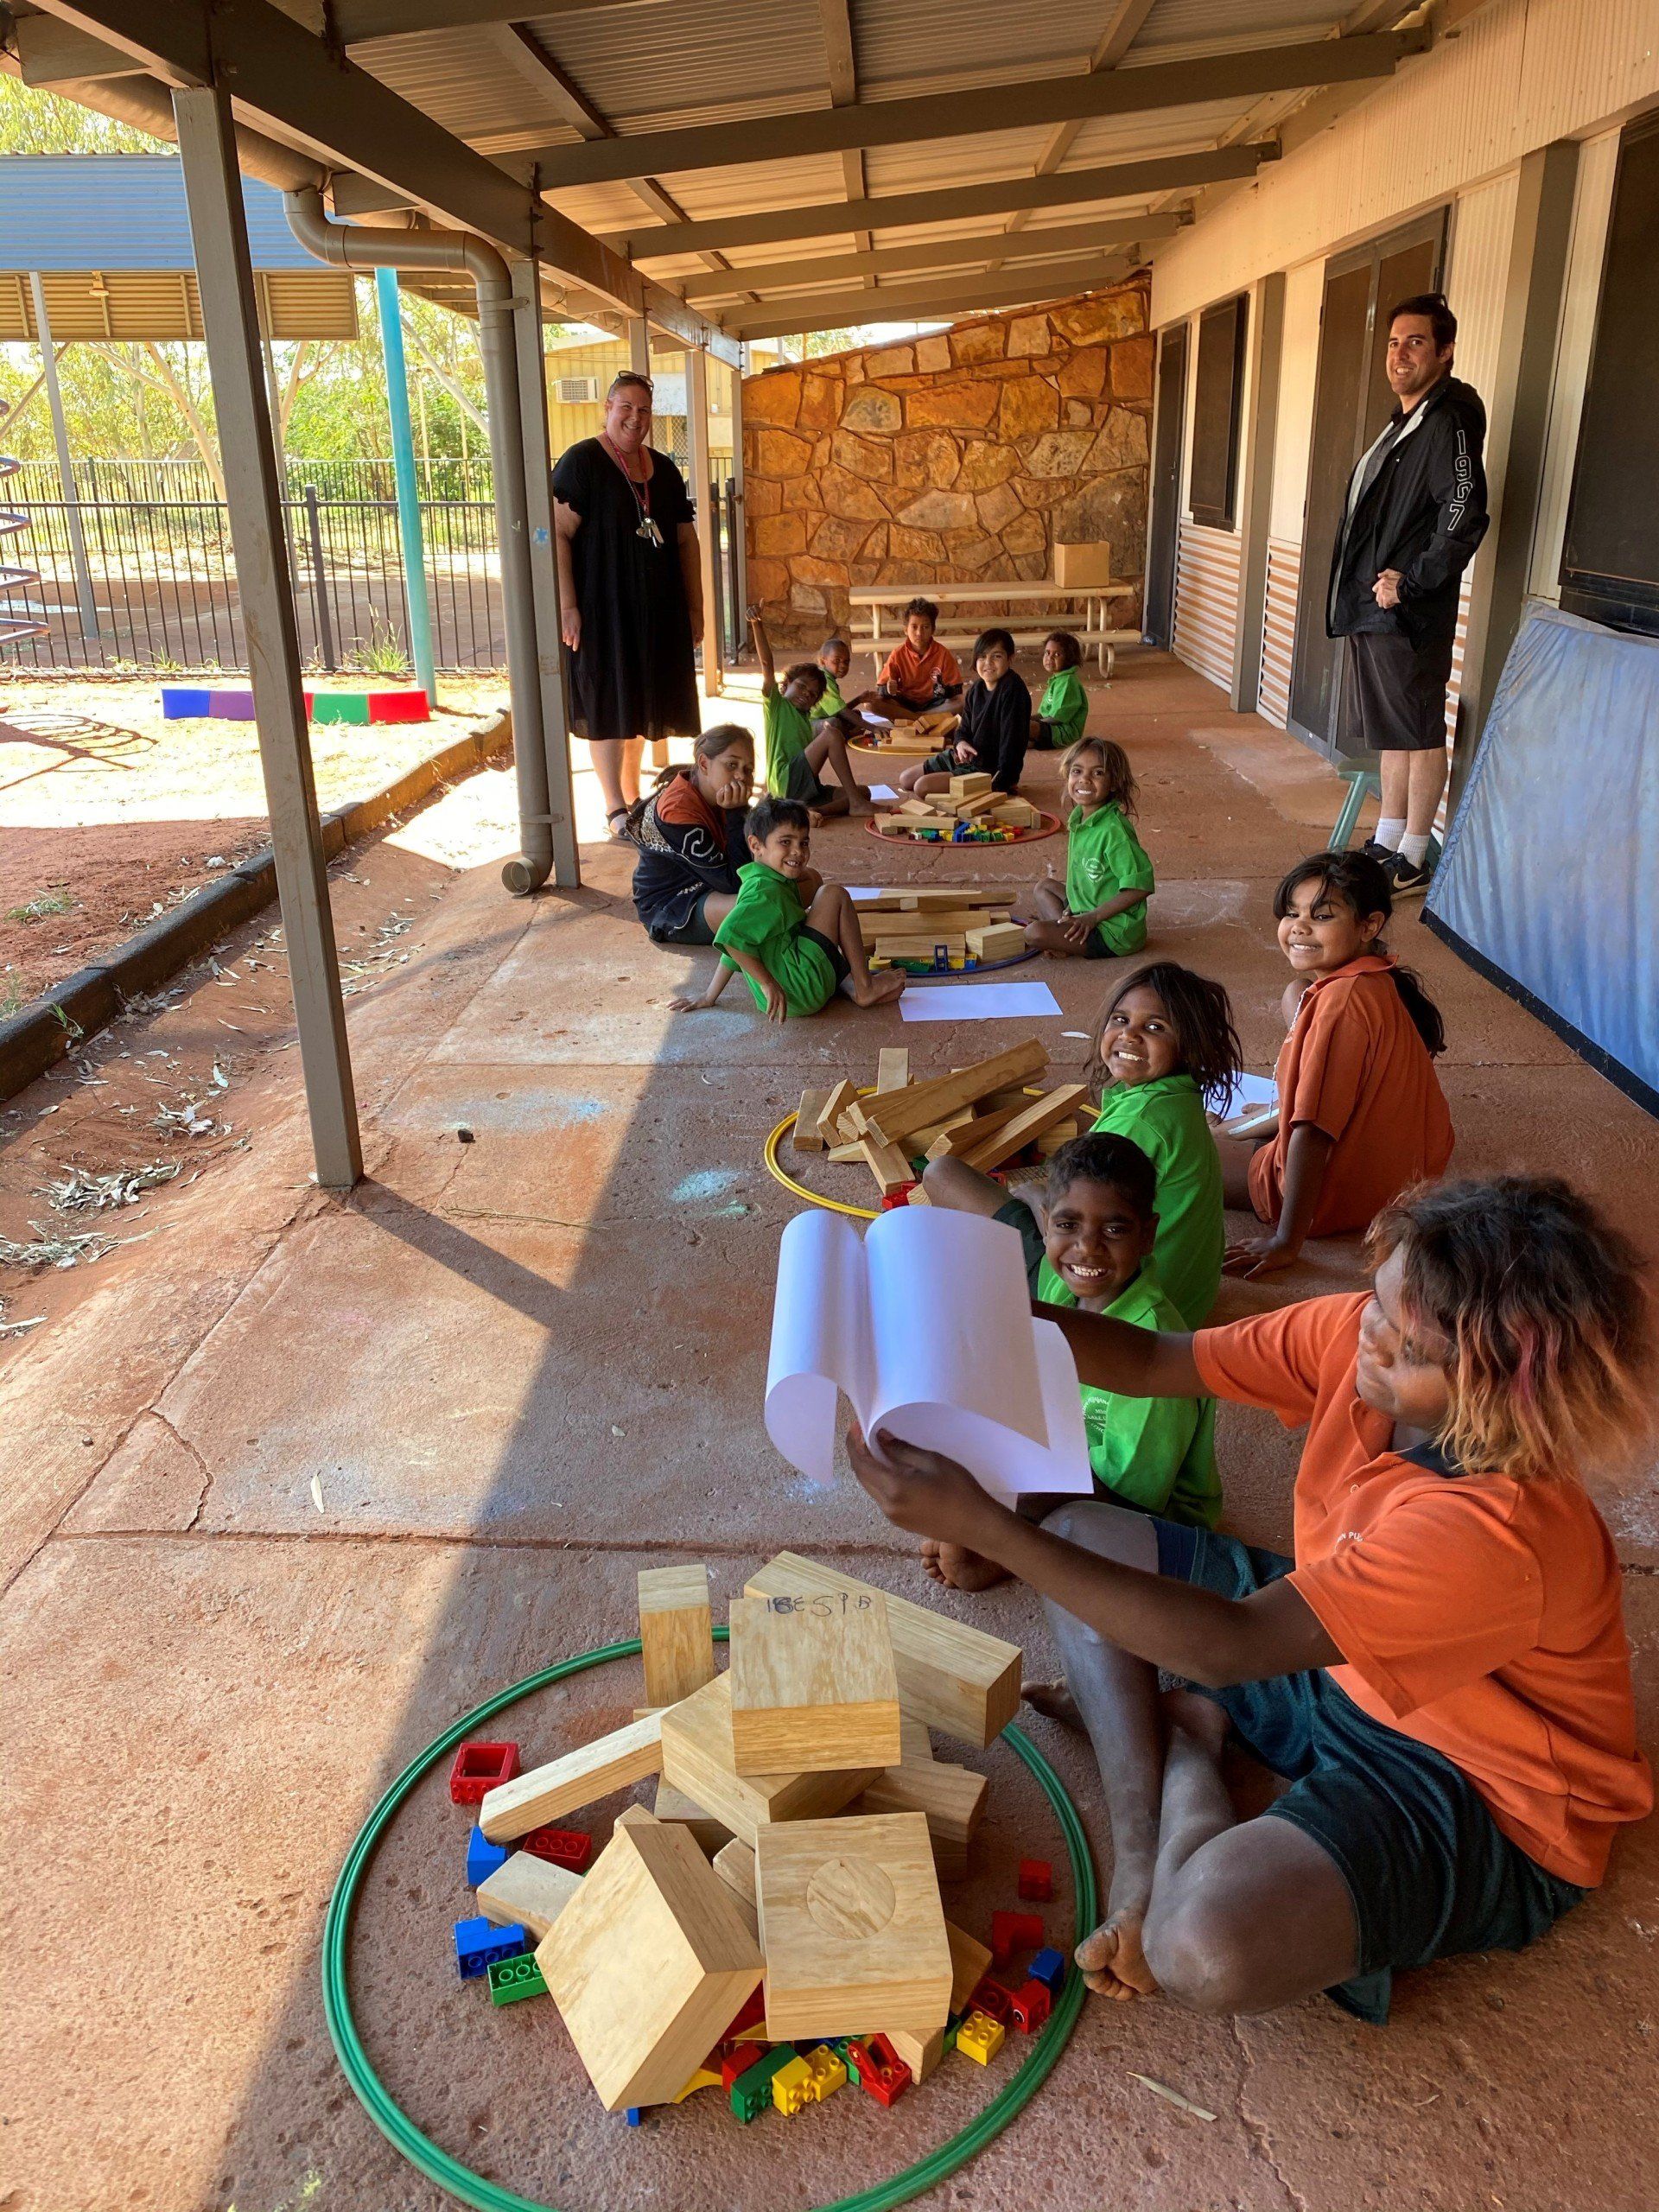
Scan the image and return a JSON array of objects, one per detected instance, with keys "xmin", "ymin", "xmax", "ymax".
[{"xmin": 0, "ymin": 455, "xmax": 734, "ymax": 675}]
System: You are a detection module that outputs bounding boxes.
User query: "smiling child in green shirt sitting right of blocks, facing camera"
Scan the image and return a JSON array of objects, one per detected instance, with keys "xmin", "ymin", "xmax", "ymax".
[{"xmin": 1011, "ymin": 736, "xmax": 1154, "ymax": 960}]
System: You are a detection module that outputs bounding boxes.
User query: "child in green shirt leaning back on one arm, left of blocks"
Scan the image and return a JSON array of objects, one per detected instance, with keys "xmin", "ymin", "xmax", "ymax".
[{"xmin": 668, "ymin": 798, "xmax": 905, "ymax": 1022}]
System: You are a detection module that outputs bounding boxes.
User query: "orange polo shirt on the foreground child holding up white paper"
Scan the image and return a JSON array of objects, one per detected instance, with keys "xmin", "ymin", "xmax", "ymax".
[{"xmin": 1192, "ymin": 1292, "xmax": 1652, "ymax": 1885}]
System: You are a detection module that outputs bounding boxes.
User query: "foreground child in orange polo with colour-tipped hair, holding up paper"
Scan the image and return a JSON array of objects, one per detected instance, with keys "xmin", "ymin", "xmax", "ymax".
[{"xmin": 849, "ymin": 1177, "xmax": 1655, "ymax": 2022}]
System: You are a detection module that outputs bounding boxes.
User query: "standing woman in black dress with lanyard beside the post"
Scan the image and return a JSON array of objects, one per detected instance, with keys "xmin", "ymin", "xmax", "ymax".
[{"xmin": 553, "ymin": 372, "xmax": 703, "ymax": 836}]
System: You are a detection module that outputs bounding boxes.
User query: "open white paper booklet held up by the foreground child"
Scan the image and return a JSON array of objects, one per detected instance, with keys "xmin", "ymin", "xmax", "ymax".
[{"xmin": 766, "ymin": 1205, "xmax": 1093, "ymax": 1502}]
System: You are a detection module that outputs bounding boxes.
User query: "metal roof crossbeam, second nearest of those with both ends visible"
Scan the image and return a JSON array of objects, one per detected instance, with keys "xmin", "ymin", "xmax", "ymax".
[{"xmin": 604, "ymin": 146, "xmax": 1279, "ymax": 261}]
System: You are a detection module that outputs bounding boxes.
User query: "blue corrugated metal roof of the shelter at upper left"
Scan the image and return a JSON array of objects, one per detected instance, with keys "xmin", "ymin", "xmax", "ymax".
[{"xmin": 0, "ymin": 153, "xmax": 340, "ymax": 274}]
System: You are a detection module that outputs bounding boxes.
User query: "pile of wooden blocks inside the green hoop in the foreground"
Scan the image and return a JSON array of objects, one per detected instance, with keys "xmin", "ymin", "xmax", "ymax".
[{"xmin": 478, "ymin": 1551, "xmax": 1035, "ymax": 2114}]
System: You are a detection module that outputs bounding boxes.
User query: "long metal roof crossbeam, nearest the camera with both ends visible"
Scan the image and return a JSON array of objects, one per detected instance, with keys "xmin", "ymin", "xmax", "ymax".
[{"xmin": 522, "ymin": 31, "xmax": 1429, "ymax": 190}]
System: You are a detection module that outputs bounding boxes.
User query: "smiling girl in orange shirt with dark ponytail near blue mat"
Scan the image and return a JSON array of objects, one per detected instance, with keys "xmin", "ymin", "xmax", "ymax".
[{"xmin": 1219, "ymin": 852, "xmax": 1451, "ymax": 1276}]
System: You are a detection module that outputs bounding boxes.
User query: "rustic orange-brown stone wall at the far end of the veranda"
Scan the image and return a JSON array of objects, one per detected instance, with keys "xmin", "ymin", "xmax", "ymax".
[{"xmin": 743, "ymin": 276, "xmax": 1153, "ymax": 644}]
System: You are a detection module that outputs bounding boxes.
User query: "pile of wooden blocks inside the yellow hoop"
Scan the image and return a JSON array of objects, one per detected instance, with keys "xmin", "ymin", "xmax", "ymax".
[{"xmin": 794, "ymin": 1038, "xmax": 1089, "ymax": 1205}]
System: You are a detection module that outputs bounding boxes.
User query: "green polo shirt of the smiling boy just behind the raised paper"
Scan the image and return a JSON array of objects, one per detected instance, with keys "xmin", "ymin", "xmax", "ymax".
[{"xmin": 998, "ymin": 1199, "xmax": 1221, "ymax": 1529}]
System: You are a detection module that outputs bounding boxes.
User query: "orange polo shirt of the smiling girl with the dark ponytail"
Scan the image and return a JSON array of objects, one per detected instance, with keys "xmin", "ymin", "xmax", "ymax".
[{"xmin": 1249, "ymin": 953, "xmax": 1451, "ymax": 1236}]
